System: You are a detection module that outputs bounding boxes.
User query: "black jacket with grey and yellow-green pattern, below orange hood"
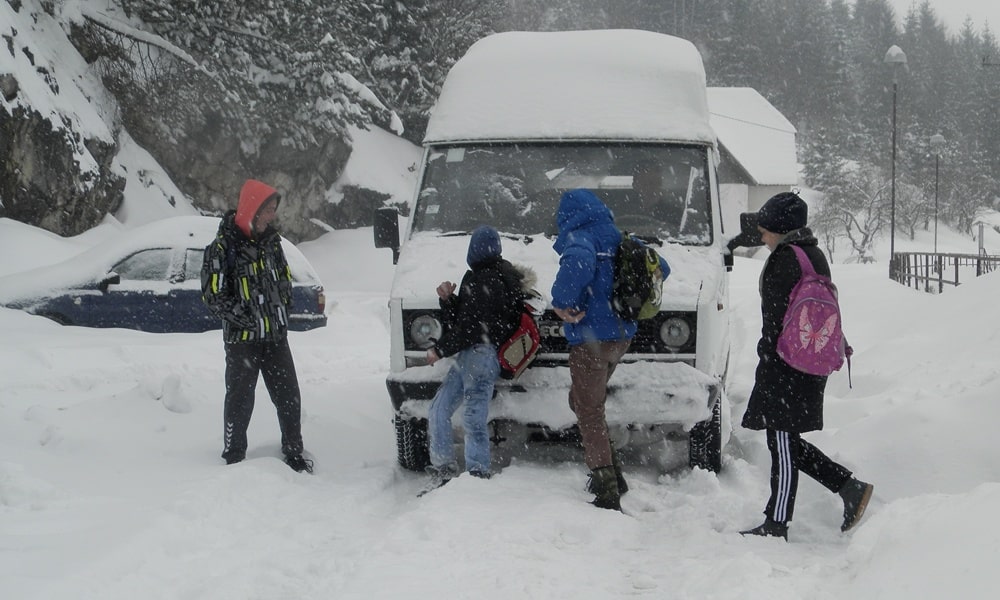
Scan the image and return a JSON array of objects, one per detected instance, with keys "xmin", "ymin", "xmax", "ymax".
[{"xmin": 201, "ymin": 212, "xmax": 292, "ymax": 342}]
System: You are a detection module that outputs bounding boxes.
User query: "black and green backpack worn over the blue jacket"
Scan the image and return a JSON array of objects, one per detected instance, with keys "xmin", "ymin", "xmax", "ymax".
[{"xmin": 611, "ymin": 231, "xmax": 663, "ymax": 321}]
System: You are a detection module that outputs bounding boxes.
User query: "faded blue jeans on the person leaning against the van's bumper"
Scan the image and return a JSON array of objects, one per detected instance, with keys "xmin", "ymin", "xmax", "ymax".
[{"xmin": 427, "ymin": 344, "xmax": 500, "ymax": 475}]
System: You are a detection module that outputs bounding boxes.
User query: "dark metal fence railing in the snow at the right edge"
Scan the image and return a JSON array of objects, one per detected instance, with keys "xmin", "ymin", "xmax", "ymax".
[{"xmin": 889, "ymin": 252, "xmax": 1000, "ymax": 293}]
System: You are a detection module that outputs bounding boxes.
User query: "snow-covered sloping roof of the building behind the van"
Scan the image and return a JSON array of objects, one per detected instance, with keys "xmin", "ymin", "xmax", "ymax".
[{"xmin": 708, "ymin": 87, "xmax": 799, "ymax": 185}]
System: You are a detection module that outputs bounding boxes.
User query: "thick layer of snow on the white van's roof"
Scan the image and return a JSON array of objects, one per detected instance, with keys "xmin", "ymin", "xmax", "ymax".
[{"xmin": 424, "ymin": 30, "xmax": 715, "ymax": 143}]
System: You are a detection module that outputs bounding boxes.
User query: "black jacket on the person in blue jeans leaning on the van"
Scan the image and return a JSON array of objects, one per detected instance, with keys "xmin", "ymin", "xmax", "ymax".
[{"xmin": 435, "ymin": 257, "xmax": 524, "ymax": 358}]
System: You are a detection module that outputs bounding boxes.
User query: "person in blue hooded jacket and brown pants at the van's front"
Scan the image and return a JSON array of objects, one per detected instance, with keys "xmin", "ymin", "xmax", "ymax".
[{"xmin": 552, "ymin": 189, "xmax": 670, "ymax": 510}]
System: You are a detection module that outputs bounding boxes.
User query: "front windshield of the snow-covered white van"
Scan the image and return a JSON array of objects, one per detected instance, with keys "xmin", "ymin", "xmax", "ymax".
[{"xmin": 413, "ymin": 143, "xmax": 712, "ymax": 245}]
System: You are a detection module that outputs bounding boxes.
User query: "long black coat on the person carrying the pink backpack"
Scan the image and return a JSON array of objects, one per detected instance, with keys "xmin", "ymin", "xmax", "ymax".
[{"xmin": 743, "ymin": 228, "xmax": 830, "ymax": 433}]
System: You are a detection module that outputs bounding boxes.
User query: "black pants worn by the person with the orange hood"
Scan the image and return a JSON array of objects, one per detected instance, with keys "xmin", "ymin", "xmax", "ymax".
[{"xmin": 222, "ymin": 338, "xmax": 302, "ymax": 460}]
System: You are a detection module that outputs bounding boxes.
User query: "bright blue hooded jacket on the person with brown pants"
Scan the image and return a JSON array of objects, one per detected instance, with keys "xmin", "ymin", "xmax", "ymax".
[{"xmin": 552, "ymin": 189, "xmax": 637, "ymax": 346}]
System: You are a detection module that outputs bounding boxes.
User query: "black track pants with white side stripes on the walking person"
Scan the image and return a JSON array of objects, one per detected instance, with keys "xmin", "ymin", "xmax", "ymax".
[{"xmin": 764, "ymin": 429, "xmax": 851, "ymax": 523}]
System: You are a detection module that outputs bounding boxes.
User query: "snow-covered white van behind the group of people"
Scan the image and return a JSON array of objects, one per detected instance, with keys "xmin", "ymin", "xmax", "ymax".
[{"xmin": 375, "ymin": 30, "xmax": 748, "ymax": 471}]
